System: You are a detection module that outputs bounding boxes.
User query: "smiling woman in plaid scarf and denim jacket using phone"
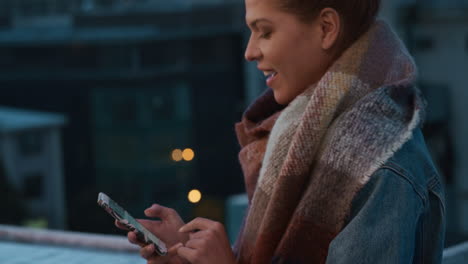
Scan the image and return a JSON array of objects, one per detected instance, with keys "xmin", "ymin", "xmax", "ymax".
[{"xmin": 117, "ymin": 0, "xmax": 445, "ymax": 264}]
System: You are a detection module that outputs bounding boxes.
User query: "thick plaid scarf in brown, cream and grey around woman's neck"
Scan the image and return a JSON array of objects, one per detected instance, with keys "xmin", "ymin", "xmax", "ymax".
[{"xmin": 235, "ymin": 21, "xmax": 424, "ymax": 264}]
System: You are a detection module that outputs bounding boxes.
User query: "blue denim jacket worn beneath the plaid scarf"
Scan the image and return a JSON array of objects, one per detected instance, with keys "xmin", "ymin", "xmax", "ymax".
[{"xmin": 327, "ymin": 130, "xmax": 445, "ymax": 264}]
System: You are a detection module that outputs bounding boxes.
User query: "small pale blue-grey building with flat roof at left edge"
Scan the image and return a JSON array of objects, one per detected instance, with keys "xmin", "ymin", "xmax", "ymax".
[{"xmin": 0, "ymin": 107, "xmax": 67, "ymax": 229}]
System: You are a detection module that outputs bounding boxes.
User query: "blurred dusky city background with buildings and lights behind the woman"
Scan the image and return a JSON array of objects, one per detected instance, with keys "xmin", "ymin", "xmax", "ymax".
[{"xmin": 0, "ymin": 0, "xmax": 468, "ymax": 250}]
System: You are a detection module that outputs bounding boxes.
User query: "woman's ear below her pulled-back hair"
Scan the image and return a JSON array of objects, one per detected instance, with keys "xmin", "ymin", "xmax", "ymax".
[{"xmin": 318, "ymin": 7, "xmax": 341, "ymax": 51}]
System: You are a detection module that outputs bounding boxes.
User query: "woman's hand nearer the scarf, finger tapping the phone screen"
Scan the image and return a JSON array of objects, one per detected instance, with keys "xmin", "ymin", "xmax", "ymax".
[{"xmin": 177, "ymin": 218, "xmax": 236, "ymax": 264}]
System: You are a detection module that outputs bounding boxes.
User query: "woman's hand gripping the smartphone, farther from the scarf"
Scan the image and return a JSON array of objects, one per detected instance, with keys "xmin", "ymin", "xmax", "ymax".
[{"xmin": 115, "ymin": 204, "xmax": 189, "ymax": 264}]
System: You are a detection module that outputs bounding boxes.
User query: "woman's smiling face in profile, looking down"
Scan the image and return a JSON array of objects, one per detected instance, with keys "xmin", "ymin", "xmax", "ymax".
[{"xmin": 245, "ymin": 0, "xmax": 332, "ymax": 105}]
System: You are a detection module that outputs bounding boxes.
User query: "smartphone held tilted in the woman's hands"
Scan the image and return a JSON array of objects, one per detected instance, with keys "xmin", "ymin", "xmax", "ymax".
[{"xmin": 98, "ymin": 192, "xmax": 167, "ymax": 256}]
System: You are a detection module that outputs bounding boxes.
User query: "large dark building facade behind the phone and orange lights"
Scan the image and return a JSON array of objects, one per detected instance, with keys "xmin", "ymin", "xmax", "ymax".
[{"xmin": 0, "ymin": 1, "xmax": 249, "ymax": 232}]
